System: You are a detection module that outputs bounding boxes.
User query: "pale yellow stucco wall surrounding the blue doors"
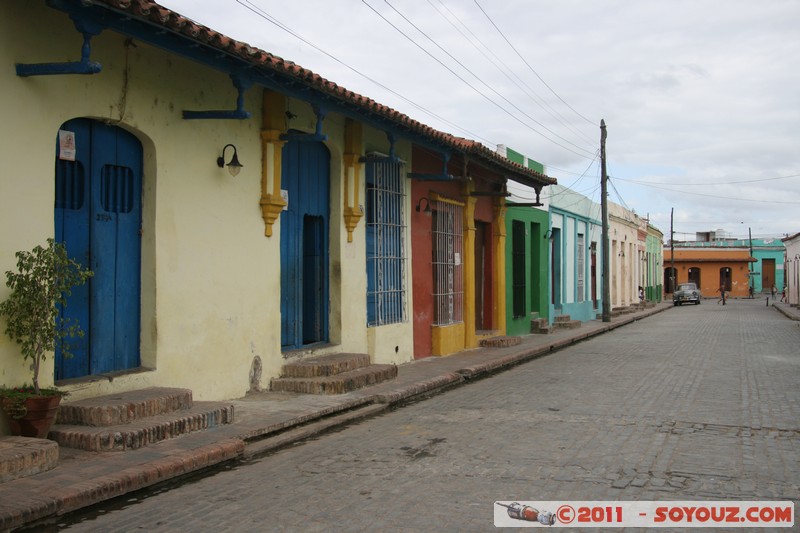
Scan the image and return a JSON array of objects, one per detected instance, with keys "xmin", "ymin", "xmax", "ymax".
[{"xmin": 0, "ymin": 2, "xmax": 412, "ymax": 408}]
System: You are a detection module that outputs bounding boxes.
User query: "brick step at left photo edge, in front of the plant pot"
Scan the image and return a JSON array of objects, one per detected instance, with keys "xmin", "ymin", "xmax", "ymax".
[{"xmin": 0, "ymin": 437, "xmax": 58, "ymax": 483}]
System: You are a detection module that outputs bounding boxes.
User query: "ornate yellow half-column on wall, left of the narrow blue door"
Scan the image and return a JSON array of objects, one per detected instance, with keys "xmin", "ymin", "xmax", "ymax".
[{"xmin": 259, "ymin": 90, "xmax": 286, "ymax": 237}]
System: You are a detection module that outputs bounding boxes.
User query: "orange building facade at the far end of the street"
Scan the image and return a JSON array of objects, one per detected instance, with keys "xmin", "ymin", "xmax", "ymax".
[{"xmin": 664, "ymin": 246, "xmax": 756, "ymax": 298}]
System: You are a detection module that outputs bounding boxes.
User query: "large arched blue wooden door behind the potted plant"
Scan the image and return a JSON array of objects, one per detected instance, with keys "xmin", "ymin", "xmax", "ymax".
[{"xmin": 55, "ymin": 119, "xmax": 142, "ymax": 379}]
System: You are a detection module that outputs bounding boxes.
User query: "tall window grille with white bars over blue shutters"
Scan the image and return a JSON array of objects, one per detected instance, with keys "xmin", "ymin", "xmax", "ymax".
[{"xmin": 366, "ymin": 159, "xmax": 406, "ymax": 326}]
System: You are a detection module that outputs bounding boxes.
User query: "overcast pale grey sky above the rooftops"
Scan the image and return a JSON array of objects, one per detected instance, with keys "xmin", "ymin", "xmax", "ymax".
[{"xmin": 162, "ymin": 0, "xmax": 800, "ymax": 240}]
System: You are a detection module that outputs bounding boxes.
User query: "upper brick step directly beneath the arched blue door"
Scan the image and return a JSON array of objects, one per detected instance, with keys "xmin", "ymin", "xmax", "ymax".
[{"xmin": 57, "ymin": 387, "xmax": 192, "ymax": 426}]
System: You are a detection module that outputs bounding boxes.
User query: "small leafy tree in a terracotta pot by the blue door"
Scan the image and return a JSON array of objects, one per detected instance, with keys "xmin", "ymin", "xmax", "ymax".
[{"xmin": 0, "ymin": 239, "xmax": 92, "ymax": 438}]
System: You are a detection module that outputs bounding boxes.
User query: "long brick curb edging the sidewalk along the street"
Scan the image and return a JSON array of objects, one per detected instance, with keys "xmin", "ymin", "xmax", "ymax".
[{"xmin": 0, "ymin": 305, "xmax": 672, "ymax": 532}]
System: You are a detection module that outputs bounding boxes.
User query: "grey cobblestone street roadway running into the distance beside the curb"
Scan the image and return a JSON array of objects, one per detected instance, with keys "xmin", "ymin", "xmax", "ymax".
[{"xmin": 53, "ymin": 300, "xmax": 800, "ymax": 532}]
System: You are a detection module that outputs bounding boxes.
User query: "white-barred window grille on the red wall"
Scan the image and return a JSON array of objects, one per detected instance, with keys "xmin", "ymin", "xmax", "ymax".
[{"xmin": 432, "ymin": 200, "xmax": 464, "ymax": 326}]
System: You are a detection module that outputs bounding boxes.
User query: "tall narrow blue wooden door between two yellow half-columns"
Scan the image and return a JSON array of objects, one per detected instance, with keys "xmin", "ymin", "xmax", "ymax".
[{"xmin": 281, "ymin": 141, "xmax": 330, "ymax": 350}]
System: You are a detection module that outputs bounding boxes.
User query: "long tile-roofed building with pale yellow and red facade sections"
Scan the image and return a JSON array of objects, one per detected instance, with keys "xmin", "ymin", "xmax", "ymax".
[{"xmin": 0, "ymin": 0, "xmax": 555, "ymax": 418}]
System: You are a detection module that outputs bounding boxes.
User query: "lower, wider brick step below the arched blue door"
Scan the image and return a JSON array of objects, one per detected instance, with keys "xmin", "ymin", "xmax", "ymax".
[{"xmin": 47, "ymin": 402, "xmax": 233, "ymax": 452}]
